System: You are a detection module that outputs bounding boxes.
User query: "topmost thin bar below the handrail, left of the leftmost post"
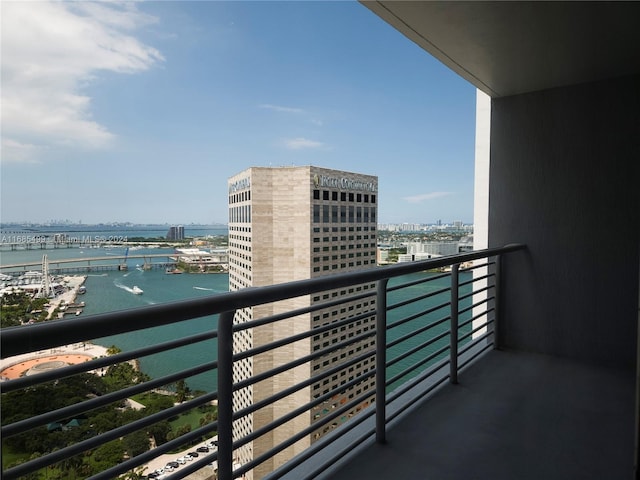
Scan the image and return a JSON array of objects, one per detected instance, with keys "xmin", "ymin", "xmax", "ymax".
[{"xmin": 0, "ymin": 330, "xmax": 218, "ymax": 393}]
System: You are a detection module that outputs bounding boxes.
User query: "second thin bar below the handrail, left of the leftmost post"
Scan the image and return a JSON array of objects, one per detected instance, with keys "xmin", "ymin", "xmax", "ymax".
[{"xmin": 0, "ymin": 362, "xmax": 217, "ymax": 437}]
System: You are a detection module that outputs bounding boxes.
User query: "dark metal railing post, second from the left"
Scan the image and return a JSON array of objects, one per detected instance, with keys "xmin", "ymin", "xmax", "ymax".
[{"xmin": 376, "ymin": 278, "xmax": 389, "ymax": 443}]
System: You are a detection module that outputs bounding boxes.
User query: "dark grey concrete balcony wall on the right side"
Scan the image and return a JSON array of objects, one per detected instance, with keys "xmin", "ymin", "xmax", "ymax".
[{"xmin": 489, "ymin": 76, "xmax": 640, "ymax": 368}]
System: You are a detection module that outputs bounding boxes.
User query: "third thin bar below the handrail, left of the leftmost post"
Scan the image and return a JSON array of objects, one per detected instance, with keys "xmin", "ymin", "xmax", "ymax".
[{"xmin": 3, "ymin": 394, "xmax": 220, "ymax": 479}]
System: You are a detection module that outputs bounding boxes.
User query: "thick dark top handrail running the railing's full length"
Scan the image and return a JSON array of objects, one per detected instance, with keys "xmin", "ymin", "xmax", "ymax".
[{"xmin": 0, "ymin": 244, "xmax": 525, "ymax": 358}]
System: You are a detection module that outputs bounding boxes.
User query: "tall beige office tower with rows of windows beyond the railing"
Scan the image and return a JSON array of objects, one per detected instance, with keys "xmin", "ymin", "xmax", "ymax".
[{"xmin": 228, "ymin": 166, "xmax": 378, "ymax": 479}]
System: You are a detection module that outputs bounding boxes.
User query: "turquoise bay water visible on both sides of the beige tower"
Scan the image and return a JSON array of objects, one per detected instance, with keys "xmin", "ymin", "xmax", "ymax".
[{"xmin": 0, "ymin": 230, "xmax": 468, "ymax": 391}]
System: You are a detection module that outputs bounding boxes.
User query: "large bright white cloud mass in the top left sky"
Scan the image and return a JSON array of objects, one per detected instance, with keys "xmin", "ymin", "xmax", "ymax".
[{"xmin": 1, "ymin": 2, "xmax": 163, "ymax": 161}]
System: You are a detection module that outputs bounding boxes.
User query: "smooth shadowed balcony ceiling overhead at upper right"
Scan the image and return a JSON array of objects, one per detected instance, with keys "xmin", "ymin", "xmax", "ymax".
[{"xmin": 362, "ymin": 0, "xmax": 640, "ymax": 97}]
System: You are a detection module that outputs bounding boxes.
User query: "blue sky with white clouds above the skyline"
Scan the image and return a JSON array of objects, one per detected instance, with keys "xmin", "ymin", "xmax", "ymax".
[{"xmin": 0, "ymin": 1, "xmax": 476, "ymax": 225}]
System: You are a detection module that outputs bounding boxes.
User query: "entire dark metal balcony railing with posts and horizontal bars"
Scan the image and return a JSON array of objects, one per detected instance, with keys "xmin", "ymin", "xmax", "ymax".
[{"xmin": 0, "ymin": 245, "xmax": 524, "ymax": 480}]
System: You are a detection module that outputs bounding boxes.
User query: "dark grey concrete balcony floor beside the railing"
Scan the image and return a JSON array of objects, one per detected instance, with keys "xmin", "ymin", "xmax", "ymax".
[{"xmin": 324, "ymin": 351, "xmax": 635, "ymax": 480}]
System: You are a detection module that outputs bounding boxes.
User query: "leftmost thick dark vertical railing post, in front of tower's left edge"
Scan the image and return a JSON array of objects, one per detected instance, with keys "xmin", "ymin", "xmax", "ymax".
[{"xmin": 217, "ymin": 311, "xmax": 235, "ymax": 480}]
